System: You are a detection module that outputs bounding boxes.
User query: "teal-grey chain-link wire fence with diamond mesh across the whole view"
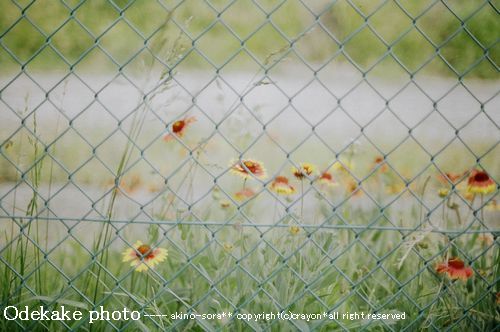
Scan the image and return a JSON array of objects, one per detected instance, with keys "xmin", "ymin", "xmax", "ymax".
[{"xmin": 0, "ymin": 0, "xmax": 500, "ymax": 330}]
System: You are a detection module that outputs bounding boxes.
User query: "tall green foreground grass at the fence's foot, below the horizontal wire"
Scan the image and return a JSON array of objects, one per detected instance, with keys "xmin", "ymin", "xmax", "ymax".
[{"xmin": 0, "ymin": 195, "xmax": 500, "ymax": 331}]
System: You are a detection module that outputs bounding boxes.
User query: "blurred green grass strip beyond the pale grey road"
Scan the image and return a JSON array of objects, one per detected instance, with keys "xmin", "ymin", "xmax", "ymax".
[{"xmin": 0, "ymin": 0, "xmax": 500, "ymax": 78}]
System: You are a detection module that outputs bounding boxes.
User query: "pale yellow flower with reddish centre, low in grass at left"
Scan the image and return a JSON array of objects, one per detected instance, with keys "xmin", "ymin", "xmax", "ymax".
[{"xmin": 122, "ymin": 241, "xmax": 168, "ymax": 272}]
